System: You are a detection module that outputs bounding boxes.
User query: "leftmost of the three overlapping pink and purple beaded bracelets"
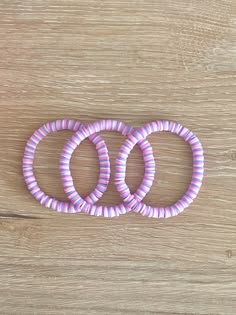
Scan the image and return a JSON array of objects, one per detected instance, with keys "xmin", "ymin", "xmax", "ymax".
[{"xmin": 22, "ymin": 119, "xmax": 110, "ymax": 213}]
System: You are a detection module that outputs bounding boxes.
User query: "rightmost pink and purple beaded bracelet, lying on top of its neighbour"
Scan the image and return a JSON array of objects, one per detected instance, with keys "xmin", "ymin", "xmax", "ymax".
[{"xmin": 115, "ymin": 121, "xmax": 204, "ymax": 218}]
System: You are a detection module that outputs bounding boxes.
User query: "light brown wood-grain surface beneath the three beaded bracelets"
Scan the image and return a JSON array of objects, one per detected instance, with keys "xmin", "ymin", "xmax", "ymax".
[{"xmin": 0, "ymin": 0, "xmax": 236, "ymax": 315}]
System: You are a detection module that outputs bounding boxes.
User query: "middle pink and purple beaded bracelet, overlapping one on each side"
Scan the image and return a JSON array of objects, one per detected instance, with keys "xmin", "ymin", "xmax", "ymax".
[{"xmin": 60, "ymin": 120, "xmax": 155, "ymax": 217}]
